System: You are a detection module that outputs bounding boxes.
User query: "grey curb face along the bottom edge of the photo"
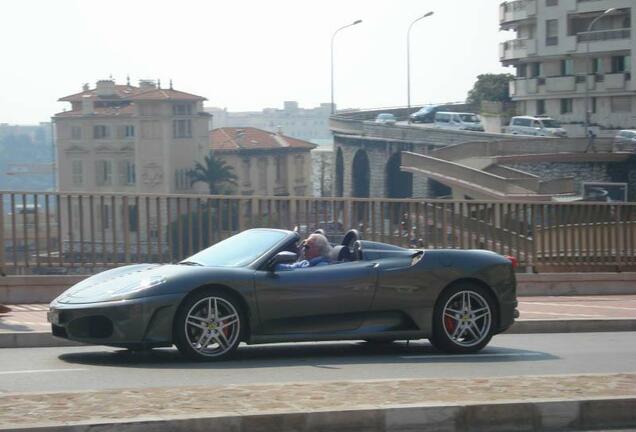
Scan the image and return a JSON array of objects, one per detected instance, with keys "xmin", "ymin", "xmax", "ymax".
[{"xmin": 0, "ymin": 397, "xmax": 636, "ymax": 432}]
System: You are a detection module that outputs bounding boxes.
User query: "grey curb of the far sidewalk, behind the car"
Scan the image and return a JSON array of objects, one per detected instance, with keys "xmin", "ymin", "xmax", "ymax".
[{"xmin": 0, "ymin": 318, "xmax": 636, "ymax": 348}]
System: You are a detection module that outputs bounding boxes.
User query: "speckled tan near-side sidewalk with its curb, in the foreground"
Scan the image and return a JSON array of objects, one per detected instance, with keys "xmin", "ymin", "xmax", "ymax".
[{"xmin": 0, "ymin": 374, "xmax": 636, "ymax": 432}]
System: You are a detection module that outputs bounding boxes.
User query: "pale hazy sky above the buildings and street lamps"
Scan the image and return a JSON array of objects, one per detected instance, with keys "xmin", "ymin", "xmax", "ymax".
[{"xmin": 0, "ymin": 0, "xmax": 514, "ymax": 124}]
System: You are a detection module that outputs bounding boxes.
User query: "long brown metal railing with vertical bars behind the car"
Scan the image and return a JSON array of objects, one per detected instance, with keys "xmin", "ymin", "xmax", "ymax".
[{"xmin": 0, "ymin": 191, "xmax": 636, "ymax": 274}]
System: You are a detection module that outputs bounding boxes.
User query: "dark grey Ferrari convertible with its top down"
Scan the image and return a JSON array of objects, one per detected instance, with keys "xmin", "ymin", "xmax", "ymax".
[{"xmin": 48, "ymin": 228, "xmax": 517, "ymax": 360}]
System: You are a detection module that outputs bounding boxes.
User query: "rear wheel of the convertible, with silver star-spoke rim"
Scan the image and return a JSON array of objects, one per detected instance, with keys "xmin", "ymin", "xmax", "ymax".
[{"xmin": 430, "ymin": 283, "xmax": 497, "ymax": 354}]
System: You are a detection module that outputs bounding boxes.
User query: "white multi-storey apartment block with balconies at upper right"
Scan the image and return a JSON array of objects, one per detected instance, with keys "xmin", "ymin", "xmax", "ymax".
[{"xmin": 499, "ymin": 0, "xmax": 636, "ymax": 136}]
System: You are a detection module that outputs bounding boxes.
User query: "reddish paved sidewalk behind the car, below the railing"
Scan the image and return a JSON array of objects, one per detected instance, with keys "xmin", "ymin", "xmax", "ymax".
[{"xmin": 0, "ymin": 295, "xmax": 636, "ymax": 348}]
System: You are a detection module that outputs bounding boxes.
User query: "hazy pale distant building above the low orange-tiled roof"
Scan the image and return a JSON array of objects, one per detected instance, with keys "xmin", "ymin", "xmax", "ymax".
[{"xmin": 206, "ymin": 101, "xmax": 331, "ymax": 141}]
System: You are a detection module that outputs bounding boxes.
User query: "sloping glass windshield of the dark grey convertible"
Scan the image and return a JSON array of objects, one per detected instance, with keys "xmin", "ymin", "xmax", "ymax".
[{"xmin": 182, "ymin": 230, "xmax": 287, "ymax": 267}]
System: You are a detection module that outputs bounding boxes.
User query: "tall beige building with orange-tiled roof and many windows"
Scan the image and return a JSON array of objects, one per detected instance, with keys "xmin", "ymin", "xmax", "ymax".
[{"xmin": 53, "ymin": 80, "xmax": 210, "ymax": 194}]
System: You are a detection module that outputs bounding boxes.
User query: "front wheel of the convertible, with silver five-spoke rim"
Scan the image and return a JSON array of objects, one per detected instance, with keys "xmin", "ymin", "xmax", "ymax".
[{"xmin": 173, "ymin": 289, "xmax": 246, "ymax": 361}]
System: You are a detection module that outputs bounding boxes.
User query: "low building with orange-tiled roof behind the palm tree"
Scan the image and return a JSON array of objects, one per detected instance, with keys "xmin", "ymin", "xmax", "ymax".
[{"xmin": 210, "ymin": 127, "xmax": 316, "ymax": 196}]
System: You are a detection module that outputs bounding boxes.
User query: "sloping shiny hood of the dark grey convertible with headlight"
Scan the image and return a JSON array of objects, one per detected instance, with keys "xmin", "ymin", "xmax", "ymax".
[{"xmin": 53, "ymin": 264, "xmax": 191, "ymax": 304}]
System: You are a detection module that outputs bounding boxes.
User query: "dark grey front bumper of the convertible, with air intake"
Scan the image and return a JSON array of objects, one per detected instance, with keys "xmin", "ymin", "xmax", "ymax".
[{"xmin": 47, "ymin": 294, "xmax": 183, "ymax": 347}]
